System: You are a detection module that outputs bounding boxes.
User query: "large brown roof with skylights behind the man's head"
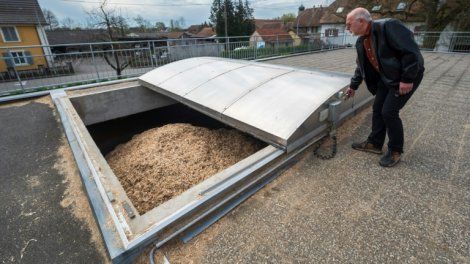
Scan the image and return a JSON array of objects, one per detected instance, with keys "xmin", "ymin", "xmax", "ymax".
[{"xmin": 320, "ymin": 0, "xmax": 425, "ymax": 24}]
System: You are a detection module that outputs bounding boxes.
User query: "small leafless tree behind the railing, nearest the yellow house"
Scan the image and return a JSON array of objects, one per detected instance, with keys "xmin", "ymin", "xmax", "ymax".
[{"xmin": 87, "ymin": 0, "xmax": 132, "ymax": 78}]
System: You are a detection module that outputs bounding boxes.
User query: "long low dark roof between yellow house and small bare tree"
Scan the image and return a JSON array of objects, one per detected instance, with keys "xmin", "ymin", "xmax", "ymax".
[{"xmin": 46, "ymin": 29, "xmax": 107, "ymax": 45}]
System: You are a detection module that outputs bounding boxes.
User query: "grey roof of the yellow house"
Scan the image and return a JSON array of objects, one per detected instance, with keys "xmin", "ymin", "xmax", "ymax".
[{"xmin": 0, "ymin": 0, "xmax": 47, "ymax": 25}]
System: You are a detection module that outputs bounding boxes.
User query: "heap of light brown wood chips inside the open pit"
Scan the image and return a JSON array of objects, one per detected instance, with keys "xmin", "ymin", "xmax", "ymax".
[{"xmin": 106, "ymin": 124, "xmax": 263, "ymax": 214}]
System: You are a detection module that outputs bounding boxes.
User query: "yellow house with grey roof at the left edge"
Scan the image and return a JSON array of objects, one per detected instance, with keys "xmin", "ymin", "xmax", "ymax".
[{"xmin": 0, "ymin": 0, "xmax": 52, "ymax": 80}]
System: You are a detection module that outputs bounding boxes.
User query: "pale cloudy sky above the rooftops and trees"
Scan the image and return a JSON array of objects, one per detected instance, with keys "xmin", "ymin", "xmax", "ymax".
[{"xmin": 39, "ymin": 0, "xmax": 332, "ymax": 27}]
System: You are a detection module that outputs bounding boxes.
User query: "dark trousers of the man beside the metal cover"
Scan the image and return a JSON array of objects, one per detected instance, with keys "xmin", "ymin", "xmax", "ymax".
[{"xmin": 368, "ymin": 72, "xmax": 423, "ymax": 153}]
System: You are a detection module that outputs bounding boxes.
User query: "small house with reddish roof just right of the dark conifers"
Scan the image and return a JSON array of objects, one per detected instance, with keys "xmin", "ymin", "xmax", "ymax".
[{"xmin": 250, "ymin": 28, "xmax": 294, "ymax": 48}]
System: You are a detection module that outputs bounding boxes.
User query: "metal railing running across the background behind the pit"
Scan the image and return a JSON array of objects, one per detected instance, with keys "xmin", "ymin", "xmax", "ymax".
[{"xmin": 0, "ymin": 32, "xmax": 470, "ymax": 96}]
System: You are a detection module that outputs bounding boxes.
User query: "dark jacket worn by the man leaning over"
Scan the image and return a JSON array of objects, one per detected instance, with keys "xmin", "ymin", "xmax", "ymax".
[{"xmin": 350, "ymin": 18, "xmax": 424, "ymax": 94}]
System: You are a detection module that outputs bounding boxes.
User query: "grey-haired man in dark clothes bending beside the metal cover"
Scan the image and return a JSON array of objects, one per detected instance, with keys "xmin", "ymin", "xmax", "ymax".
[{"xmin": 346, "ymin": 8, "xmax": 424, "ymax": 167}]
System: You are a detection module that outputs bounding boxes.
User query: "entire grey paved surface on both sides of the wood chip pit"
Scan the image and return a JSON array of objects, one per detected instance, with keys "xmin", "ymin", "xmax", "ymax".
[{"xmin": 0, "ymin": 50, "xmax": 470, "ymax": 263}]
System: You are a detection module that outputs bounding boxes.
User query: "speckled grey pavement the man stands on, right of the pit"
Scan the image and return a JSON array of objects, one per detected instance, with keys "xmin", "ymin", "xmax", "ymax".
[{"xmin": 154, "ymin": 50, "xmax": 470, "ymax": 263}]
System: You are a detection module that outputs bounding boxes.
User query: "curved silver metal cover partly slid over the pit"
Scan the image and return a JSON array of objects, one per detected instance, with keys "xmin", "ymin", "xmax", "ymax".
[{"xmin": 139, "ymin": 57, "xmax": 349, "ymax": 147}]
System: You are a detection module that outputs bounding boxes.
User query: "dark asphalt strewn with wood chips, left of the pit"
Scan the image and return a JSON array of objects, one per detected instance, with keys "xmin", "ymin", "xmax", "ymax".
[{"xmin": 0, "ymin": 98, "xmax": 106, "ymax": 263}]
